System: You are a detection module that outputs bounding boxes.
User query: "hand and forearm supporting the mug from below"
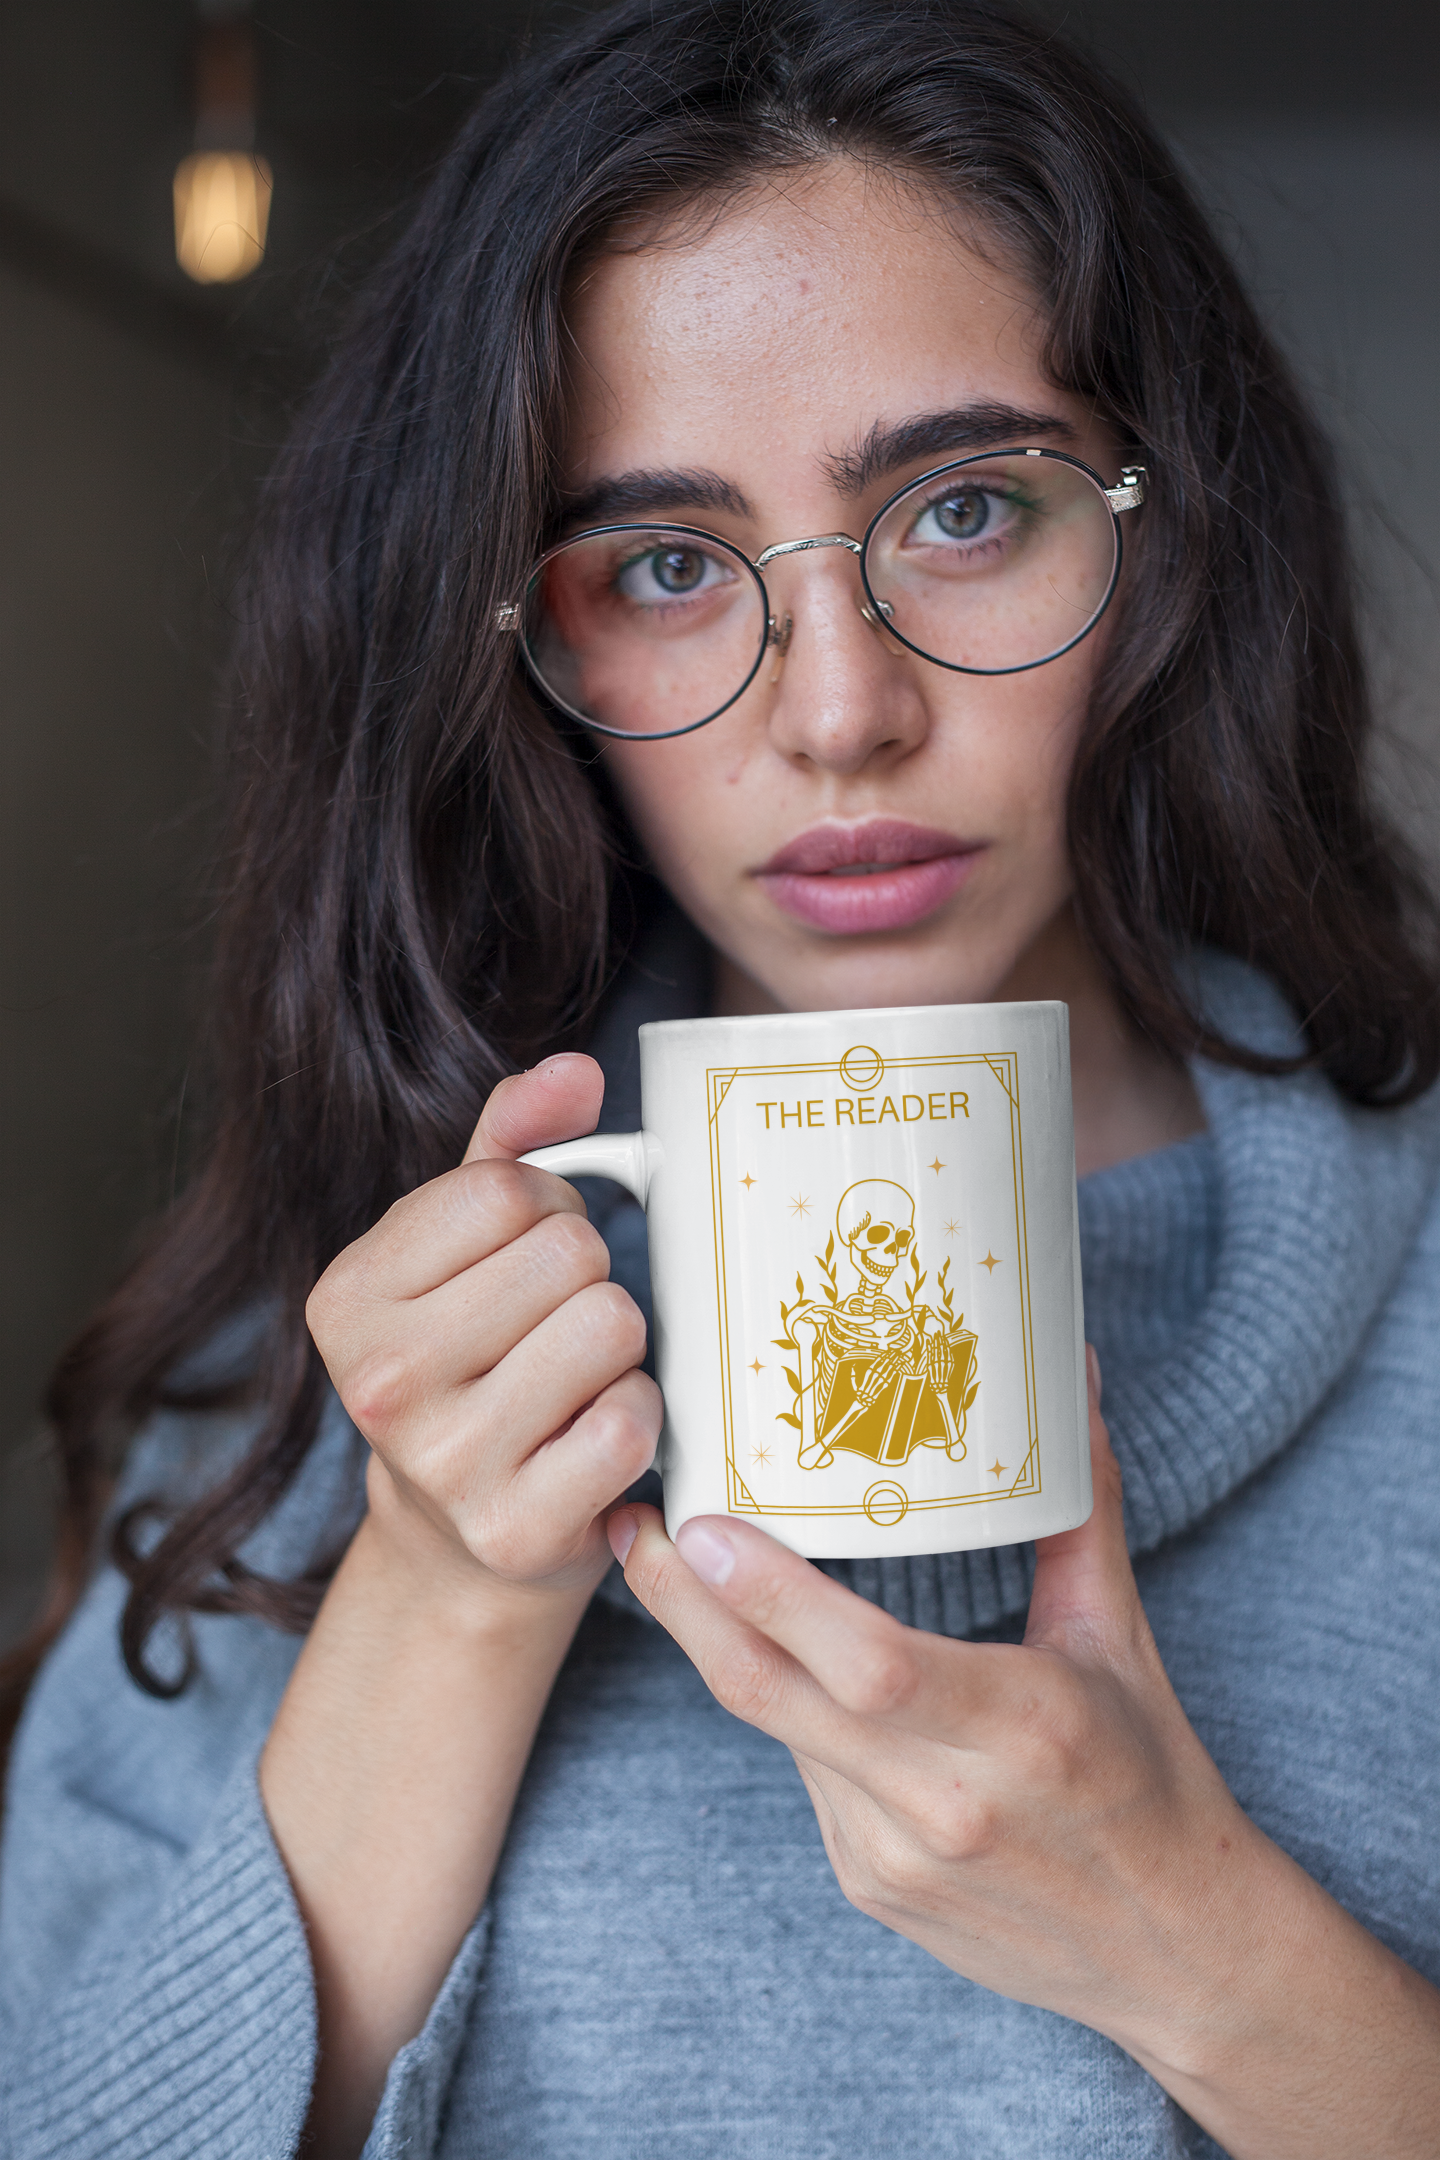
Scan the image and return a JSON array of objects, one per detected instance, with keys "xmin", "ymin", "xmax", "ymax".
[{"xmin": 609, "ymin": 1352, "xmax": 1440, "ymax": 2160}]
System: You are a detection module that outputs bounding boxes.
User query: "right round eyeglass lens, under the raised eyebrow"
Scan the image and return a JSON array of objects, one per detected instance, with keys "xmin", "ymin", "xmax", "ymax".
[{"xmin": 866, "ymin": 456, "xmax": 1118, "ymax": 674}]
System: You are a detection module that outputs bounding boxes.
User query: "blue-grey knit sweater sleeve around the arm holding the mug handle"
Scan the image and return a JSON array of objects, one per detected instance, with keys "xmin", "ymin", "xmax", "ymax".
[{"xmin": 0, "ymin": 1399, "xmax": 486, "ymax": 2160}]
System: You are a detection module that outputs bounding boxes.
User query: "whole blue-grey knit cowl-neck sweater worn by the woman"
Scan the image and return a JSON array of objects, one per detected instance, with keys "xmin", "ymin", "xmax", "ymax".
[{"xmin": 0, "ymin": 961, "xmax": 1440, "ymax": 2160}]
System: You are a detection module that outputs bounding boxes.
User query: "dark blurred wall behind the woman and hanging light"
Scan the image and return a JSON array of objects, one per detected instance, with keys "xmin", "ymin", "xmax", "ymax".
[{"xmin": 0, "ymin": 0, "xmax": 1440, "ymax": 1639}]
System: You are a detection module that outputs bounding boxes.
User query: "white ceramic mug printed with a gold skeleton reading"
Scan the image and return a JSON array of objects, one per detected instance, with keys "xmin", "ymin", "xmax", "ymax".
[{"xmin": 522, "ymin": 1004, "xmax": 1090, "ymax": 1560}]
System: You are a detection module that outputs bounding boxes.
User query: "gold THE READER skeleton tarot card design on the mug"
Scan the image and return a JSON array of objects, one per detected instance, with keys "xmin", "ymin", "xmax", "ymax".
[{"xmin": 706, "ymin": 1043, "xmax": 1041, "ymax": 1520}]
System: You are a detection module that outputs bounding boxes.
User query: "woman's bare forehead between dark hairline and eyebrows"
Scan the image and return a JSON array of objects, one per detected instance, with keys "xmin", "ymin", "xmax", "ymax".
[{"xmin": 563, "ymin": 162, "xmax": 1084, "ymax": 492}]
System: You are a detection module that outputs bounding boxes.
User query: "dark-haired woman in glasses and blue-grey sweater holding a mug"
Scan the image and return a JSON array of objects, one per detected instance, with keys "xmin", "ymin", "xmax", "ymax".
[{"xmin": 4, "ymin": 0, "xmax": 1440, "ymax": 2160}]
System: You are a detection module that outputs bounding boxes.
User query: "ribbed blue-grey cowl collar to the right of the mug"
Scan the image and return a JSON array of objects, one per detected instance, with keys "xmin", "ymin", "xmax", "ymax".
[{"xmin": 1082, "ymin": 953, "xmax": 1440, "ymax": 1551}]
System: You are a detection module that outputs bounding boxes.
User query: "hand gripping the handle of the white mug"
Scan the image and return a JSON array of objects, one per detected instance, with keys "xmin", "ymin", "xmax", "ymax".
[{"xmin": 307, "ymin": 1056, "xmax": 661, "ymax": 1603}]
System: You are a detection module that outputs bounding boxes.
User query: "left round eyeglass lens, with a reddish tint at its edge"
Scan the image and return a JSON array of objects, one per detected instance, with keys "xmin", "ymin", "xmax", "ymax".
[{"xmin": 525, "ymin": 525, "xmax": 766, "ymax": 734}]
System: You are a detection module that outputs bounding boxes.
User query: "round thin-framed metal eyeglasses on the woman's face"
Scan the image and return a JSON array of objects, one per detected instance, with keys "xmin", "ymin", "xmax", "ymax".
[{"xmin": 499, "ymin": 449, "xmax": 1144, "ymax": 739}]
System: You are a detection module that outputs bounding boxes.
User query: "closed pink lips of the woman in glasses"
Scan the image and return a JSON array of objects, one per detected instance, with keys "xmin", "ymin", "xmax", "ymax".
[{"xmin": 756, "ymin": 819, "xmax": 980, "ymax": 937}]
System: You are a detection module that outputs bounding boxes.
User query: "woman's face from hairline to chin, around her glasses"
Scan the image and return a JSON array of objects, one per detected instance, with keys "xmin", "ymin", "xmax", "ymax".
[{"xmin": 566, "ymin": 162, "xmax": 1118, "ymax": 1011}]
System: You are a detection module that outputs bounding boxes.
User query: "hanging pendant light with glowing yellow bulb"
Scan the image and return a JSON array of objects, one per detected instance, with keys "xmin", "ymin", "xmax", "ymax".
[{"xmin": 175, "ymin": 0, "xmax": 272, "ymax": 285}]
